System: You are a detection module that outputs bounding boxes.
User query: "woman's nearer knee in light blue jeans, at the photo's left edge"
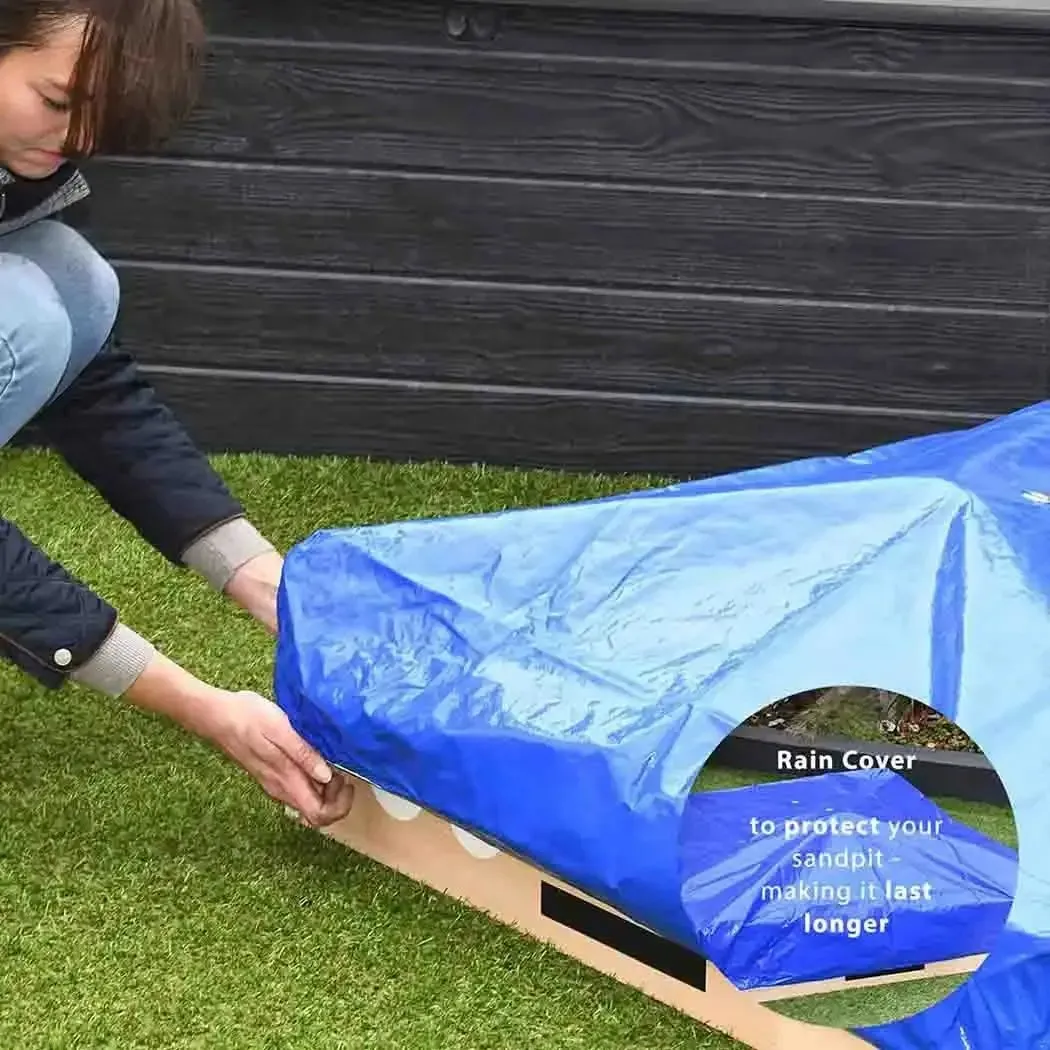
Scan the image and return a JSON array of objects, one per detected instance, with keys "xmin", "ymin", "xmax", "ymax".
[{"xmin": 0, "ymin": 253, "xmax": 72, "ymax": 445}]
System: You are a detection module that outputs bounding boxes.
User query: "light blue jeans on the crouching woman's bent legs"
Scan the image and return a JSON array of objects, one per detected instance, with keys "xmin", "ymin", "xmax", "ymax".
[{"xmin": 0, "ymin": 219, "xmax": 120, "ymax": 447}]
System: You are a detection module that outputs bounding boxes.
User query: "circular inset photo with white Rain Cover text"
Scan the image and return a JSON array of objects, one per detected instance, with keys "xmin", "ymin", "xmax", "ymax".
[{"xmin": 679, "ymin": 686, "xmax": 1017, "ymax": 1030}]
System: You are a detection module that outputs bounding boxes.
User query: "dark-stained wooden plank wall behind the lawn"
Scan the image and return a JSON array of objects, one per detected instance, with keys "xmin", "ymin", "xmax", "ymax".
[{"xmin": 65, "ymin": 0, "xmax": 1050, "ymax": 476}]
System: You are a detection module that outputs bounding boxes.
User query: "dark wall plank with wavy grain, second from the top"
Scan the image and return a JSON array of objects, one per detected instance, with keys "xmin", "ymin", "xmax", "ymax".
[{"xmin": 169, "ymin": 45, "xmax": 1050, "ymax": 202}]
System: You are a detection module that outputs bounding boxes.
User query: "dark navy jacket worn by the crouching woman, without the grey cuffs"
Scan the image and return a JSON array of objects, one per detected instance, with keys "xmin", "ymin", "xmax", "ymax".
[{"xmin": 0, "ymin": 161, "xmax": 244, "ymax": 688}]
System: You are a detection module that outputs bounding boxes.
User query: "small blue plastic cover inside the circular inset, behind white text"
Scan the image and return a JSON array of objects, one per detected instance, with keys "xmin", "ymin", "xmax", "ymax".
[{"xmin": 681, "ymin": 770, "xmax": 1017, "ymax": 988}]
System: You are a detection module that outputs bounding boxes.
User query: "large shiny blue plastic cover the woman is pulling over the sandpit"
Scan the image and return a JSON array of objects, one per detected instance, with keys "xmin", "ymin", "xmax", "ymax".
[{"xmin": 274, "ymin": 396, "xmax": 1050, "ymax": 1050}]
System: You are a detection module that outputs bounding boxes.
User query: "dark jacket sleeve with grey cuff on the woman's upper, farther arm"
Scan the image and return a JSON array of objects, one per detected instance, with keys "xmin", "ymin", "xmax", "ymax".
[{"xmin": 35, "ymin": 336, "xmax": 273, "ymax": 589}]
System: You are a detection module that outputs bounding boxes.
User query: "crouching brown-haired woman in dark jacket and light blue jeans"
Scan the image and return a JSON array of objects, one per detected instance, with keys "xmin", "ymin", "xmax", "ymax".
[{"xmin": 0, "ymin": 0, "xmax": 351, "ymax": 826}]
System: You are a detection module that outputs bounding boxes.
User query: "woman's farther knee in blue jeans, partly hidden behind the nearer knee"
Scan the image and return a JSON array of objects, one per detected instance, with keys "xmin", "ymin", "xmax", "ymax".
[{"xmin": 0, "ymin": 219, "xmax": 121, "ymax": 373}]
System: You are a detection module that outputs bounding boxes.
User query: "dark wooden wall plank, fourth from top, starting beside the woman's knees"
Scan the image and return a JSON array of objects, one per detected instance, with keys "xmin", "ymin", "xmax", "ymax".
[{"xmin": 120, "ymin": 264, "xmax": 1050, "ymax": 414}]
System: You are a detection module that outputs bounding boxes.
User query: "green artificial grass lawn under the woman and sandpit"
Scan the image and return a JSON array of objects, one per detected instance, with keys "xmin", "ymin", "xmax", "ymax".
[{"xmin": 0, "ymin": 450, "xmax": 1016, "ymax": 1050}]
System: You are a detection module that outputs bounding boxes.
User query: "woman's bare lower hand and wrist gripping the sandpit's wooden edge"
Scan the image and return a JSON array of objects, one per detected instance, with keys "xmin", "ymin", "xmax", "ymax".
[{"xmin": 124, "ymin": 653, "xmax": 353, "ymax": 827}]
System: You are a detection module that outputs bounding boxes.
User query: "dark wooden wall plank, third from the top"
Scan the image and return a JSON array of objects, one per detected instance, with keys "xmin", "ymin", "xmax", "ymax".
[{"xmin": 71, "ymin": 160, "xmax": 1048, "ymax": 309}]
